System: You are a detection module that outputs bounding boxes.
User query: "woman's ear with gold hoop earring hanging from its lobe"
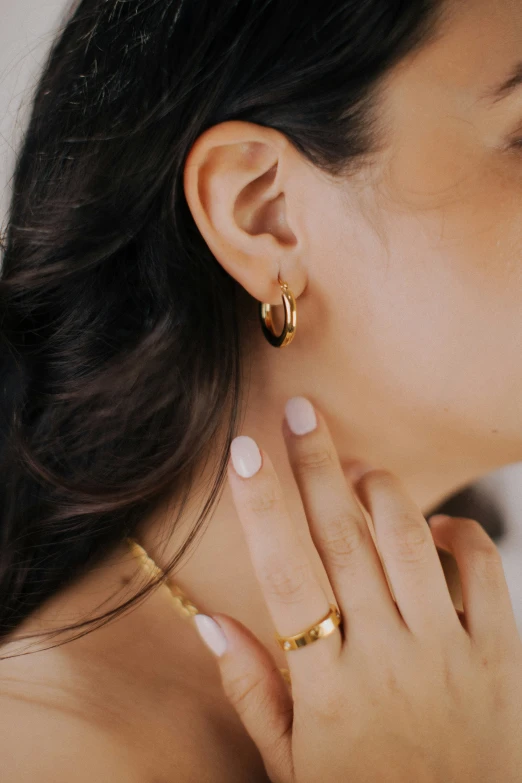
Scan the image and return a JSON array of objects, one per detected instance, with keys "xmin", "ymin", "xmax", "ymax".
[{"xmin": 184, "ymin": 121, "xmax": 306, "ymax": 305}]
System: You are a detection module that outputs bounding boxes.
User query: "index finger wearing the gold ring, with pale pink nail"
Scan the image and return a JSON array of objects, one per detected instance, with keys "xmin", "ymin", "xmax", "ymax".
[{"xmin": 228, "ymin": 435, "xmax": 342, "ymax": 680}]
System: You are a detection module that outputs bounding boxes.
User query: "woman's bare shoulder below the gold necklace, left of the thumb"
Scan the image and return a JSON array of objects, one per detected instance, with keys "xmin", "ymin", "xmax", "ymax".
[{"xmin": 0, "ymin": 586, "xmax": 268, "ymax": 783}]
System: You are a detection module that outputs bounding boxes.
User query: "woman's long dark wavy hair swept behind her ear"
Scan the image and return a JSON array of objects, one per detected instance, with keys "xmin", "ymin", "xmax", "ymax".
[{"xmin": 0, "ymin": 0, "xmax": 442, "ymax": 657}]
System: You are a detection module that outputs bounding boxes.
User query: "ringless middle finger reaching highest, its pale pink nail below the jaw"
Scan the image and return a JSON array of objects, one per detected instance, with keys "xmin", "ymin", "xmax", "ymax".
[{"xmin": 283, "ymin": 397, "xmax": 402, "ymax": 630}]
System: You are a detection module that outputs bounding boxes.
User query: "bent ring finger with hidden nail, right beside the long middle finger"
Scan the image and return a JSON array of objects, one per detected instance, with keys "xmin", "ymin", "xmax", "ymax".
[{"xmin": 356, "ymin": 470, "xmax": 462, "ymax": 635}]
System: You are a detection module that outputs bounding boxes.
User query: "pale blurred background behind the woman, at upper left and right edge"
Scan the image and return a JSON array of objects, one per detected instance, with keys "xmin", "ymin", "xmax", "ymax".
[{"xmin": 0, "ymin": 0, "xmax": 522, "ymax": 631}]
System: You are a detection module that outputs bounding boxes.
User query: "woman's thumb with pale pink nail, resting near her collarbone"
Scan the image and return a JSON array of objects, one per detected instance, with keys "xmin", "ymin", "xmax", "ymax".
[{"xmin": 194, "ymin": 613, "xmax": 295, "ymax": 783}]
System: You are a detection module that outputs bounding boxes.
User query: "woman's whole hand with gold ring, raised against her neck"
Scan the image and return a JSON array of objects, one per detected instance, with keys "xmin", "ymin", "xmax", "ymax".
[{"xmin": 208, "ymin": 401, "xmax": 522, "ymax": 783}]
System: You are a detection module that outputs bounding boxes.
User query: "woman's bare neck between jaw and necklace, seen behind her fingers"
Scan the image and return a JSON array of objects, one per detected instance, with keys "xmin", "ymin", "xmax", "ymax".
[{"xmin": 139, "ymin": 372, "xmax": 502, "ymax": 667}]
